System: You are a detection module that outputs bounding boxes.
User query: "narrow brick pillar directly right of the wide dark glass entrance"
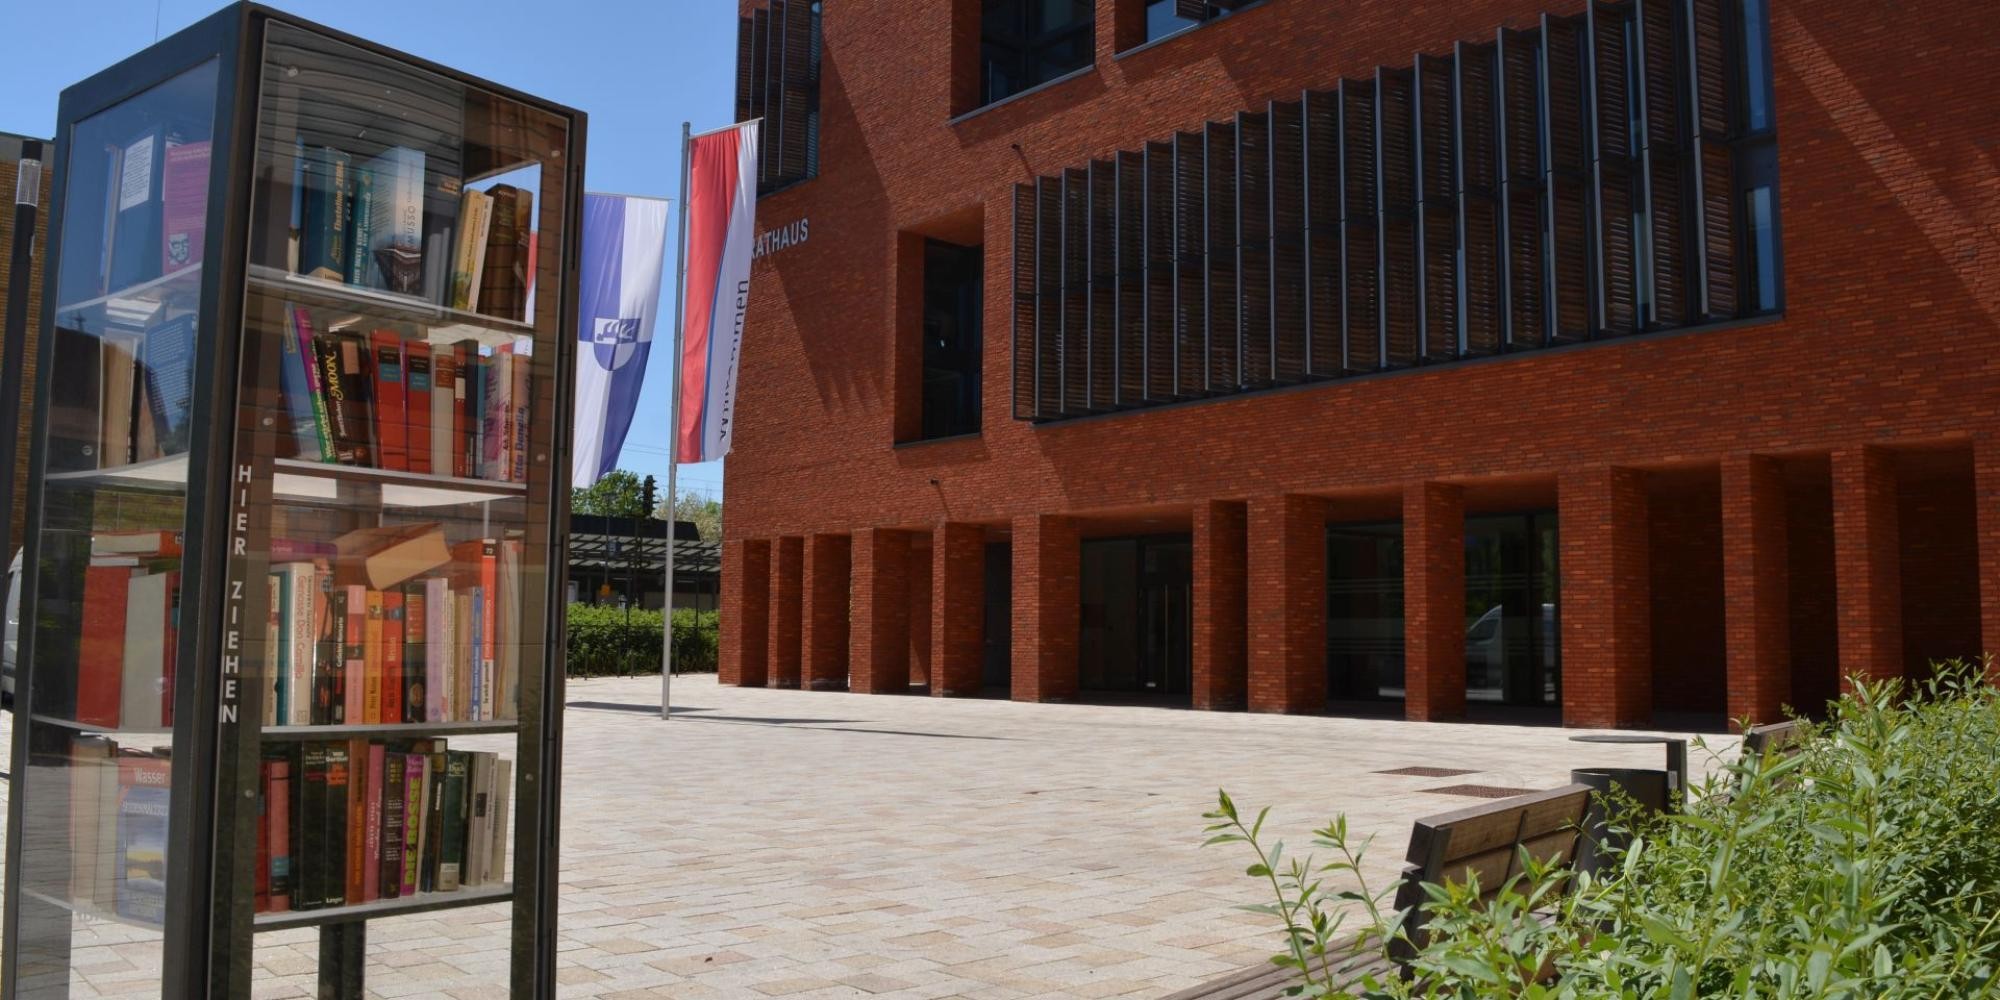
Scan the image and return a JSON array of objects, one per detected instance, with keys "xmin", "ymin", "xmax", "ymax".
[{"xmin": 1192, "ymin": 500, "xmax": 1250, "ymax": 712}]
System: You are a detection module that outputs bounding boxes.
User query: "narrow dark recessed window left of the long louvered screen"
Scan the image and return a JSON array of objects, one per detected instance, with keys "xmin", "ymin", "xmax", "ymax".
[{"xmin": 924, "ymin": 240, "xmax": 984, "ymax": 440}]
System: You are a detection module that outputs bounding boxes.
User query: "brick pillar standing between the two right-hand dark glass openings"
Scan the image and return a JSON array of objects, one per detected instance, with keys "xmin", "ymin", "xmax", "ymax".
[{"xmin": 1402, "ymin": 482, "xmax": 1466, "ymax": 722}]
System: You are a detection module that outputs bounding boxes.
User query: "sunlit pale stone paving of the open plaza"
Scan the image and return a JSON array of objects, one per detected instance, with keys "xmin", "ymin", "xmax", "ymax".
[{"xmin": 0, "ymin": 676, "xmax": 1726, "ymax": 1000}]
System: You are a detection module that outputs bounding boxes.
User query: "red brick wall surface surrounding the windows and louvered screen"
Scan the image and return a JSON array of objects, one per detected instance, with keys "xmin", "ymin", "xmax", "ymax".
[{"xmin": 726, "ymin": 0, "xmax": 2000, "ymax": 720}]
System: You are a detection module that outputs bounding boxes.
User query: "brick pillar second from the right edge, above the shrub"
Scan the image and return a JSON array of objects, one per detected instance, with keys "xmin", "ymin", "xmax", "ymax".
[{"xmin": 1834, "ymin": 446, "xmax": 1904, "ymax": 688}]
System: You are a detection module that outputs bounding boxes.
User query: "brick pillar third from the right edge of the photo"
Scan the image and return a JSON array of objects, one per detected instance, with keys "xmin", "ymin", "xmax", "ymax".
[{"xmin": 1722, "ymin": 454, "xmax": 1792, "ymax": 726}]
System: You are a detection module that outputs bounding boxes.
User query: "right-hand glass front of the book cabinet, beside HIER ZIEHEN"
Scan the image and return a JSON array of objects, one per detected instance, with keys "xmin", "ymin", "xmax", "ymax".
[{"xmin": 230, "ymin": 24, "xmax": 568, "ymax": 992}]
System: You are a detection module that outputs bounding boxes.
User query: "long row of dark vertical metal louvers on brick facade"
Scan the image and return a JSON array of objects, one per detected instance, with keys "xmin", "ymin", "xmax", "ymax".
[{"xmin": 1008, "ymin": 0, "xmax": 1772, "ymax": 420}]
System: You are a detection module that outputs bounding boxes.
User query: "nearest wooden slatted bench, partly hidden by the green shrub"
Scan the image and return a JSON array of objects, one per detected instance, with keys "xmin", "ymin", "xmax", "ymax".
[{"xmin": 1166, "ymin": 784, "xmax": 1590, "ymax": 1000}]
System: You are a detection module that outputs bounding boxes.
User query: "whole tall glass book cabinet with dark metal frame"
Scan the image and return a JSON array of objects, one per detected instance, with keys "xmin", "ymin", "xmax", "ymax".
[{"xmin": 4, "ymin": 4, "xmax": 584, "ymax": 998}]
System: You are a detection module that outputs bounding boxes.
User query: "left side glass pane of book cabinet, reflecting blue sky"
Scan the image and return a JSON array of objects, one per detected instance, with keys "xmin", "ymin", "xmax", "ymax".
[{"xmin": 10, "ymin": 52, "xmax": 218, "ymax": 996}]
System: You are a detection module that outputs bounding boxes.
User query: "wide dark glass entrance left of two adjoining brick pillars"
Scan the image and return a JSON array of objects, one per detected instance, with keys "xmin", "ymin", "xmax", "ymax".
[{"xmin": 1078, "ymin": 534, "xmax": 1194, "ymax": 700}]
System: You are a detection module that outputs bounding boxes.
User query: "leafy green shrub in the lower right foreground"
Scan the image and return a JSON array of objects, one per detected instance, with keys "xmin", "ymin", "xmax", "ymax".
[{"xmin": 1210, "ymin": 662, "xmax": 2000, "ymax": 1000}]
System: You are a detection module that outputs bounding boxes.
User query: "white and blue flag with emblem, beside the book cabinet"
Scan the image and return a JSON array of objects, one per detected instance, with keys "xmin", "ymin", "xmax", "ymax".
[{"xmin": 570, "ymin": 194, "xmax": 666, "ymax": 486}]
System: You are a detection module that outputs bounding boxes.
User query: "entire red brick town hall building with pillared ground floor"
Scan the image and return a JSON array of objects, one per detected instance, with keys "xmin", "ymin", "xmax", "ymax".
[{"xmin": 722, "ymin": 0, "xmax": 2000, "ymax": 726}]
